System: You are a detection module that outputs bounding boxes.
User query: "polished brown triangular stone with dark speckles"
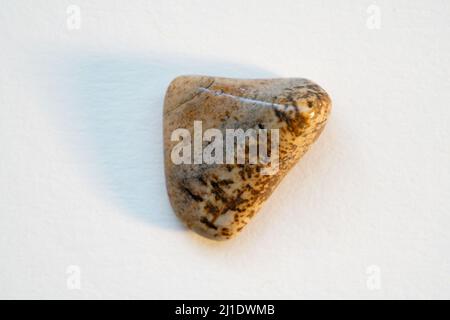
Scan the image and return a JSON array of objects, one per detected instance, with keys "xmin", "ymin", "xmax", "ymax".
[{"xmin": 163, "ymin": 76, "xmax": 331, "ymax": 240}]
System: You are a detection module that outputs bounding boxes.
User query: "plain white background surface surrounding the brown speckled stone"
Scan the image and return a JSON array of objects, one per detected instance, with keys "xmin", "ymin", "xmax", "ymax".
[{"xmin": 0, "ymin": 0, "xmax": 450, "ymax": 299}]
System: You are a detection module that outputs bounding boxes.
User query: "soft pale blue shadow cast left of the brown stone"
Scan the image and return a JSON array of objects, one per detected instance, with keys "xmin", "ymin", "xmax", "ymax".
[{"xmin": 56, "ymin": 52, "xmax": 272, "ymax": 230}]
